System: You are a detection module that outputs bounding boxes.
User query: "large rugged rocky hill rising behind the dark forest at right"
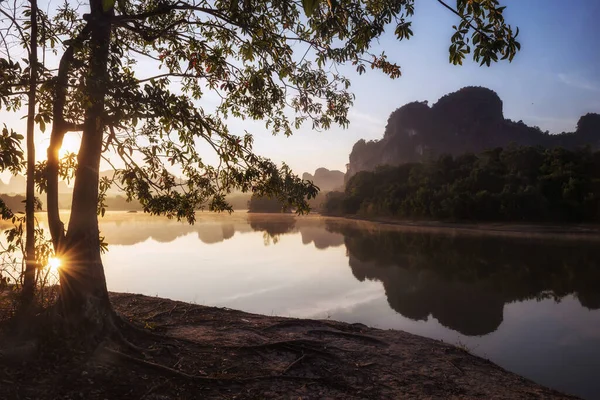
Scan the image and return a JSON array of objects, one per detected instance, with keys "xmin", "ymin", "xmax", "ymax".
[{"xmin": 346, "ymin": 87, "xmax": 600, "ymax": 180}]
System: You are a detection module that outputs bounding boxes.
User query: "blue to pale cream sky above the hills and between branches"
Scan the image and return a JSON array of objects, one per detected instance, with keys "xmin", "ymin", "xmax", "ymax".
[{"xmin": 0, "ymin": 0, "xmax": 600, "ymax": 180}]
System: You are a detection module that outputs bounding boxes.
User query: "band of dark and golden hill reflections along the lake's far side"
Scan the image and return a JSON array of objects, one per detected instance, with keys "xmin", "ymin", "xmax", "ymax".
[{"xmin": 95, "ymin": 214, "xmax": 600, "ymax": 335}]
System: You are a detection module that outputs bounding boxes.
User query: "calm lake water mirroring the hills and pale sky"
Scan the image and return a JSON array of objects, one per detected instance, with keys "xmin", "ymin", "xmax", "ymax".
[{"xmin": 35, "ymin": 212, "xmax": 600, "ymax": 399}]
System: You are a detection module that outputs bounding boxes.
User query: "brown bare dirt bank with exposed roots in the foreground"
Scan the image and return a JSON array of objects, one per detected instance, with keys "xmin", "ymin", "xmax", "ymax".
[{"xmin": 0, "ymin": 293, "xmax": 572, "ymax": 400}]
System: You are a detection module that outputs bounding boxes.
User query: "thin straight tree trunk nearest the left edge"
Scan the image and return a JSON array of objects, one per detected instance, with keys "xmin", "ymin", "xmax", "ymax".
[{"xmin": 23, "ymin": 0, "xmax": 38, "ymax": 305}]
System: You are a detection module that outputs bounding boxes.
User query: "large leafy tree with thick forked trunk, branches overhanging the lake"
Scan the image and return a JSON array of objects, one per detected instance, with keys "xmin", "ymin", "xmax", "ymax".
[{"xmin": 4, "ymin": 0, "xmax": 519, "ymax": 334}]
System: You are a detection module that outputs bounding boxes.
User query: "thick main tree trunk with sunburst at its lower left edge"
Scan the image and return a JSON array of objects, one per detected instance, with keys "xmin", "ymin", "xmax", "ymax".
[{"xmin": 60, "ymin": 0, "xmax": 113, "ymax": 328}]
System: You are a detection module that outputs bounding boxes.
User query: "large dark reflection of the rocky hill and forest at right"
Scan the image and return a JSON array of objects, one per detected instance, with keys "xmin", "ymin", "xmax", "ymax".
[{"xmin": 327, "ymin": 222, "xmax": 600, "ymax": 335}]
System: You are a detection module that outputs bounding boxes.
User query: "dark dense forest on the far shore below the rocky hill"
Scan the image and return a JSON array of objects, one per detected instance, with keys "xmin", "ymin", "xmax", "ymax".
[{"xmin": 323, "ymin": 146, "xmax": 600, "ymax": 222}]
